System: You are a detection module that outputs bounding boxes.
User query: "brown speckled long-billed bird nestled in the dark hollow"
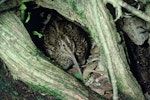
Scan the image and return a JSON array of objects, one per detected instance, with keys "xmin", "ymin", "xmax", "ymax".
[{"xmin": 44, "ymin": 20, "xmax": 88, "ymax": 73}]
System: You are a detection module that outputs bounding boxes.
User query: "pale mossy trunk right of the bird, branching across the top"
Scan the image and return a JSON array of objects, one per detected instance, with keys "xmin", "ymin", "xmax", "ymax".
[{"xmin": 36, "ymin": 0, "xmax": 144, "ymax": 100}]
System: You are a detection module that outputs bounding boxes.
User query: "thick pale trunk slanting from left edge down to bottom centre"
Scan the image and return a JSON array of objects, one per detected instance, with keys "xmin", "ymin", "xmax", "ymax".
[{"xmin": 0, "ymin": 12, "xmax": 103, "ymax": 100}]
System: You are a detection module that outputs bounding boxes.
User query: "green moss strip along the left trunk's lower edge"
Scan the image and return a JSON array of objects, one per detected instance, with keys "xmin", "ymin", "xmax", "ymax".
[{"xmin": 28, "ymin": 83, "xmax": 65, "ymax": 100}]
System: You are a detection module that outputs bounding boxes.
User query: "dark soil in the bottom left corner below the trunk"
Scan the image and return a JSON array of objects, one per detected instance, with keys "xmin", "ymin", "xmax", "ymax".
[{"xmin": 0, "ymin": 62, "xmax": 56, "ymax": 100}]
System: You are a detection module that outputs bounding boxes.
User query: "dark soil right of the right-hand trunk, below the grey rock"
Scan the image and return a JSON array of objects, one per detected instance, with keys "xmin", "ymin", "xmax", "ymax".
[{"xmin": 126, "ymin": 36, "xmax": 150, "ymax": 95}]
